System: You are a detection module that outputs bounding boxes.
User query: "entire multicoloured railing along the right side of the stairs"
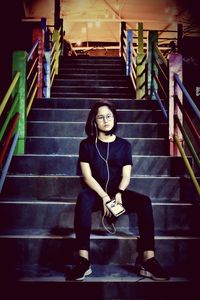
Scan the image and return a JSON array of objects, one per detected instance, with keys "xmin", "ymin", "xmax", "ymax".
[{"xmin": 121, "ymin": 23, "xmax": 200, "ymax": 195}]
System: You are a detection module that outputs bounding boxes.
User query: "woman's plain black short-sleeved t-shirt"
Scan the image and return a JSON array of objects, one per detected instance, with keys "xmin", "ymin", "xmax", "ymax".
[{"xmin": 79, "ymin": 137, "xmax": 132, "ymax": 191}]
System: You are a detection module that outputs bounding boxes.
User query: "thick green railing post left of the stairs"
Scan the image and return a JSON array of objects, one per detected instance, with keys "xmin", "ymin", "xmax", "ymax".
[{"xmin": 12, "ymin": 51, "xmax": 28, "ymax": 154}]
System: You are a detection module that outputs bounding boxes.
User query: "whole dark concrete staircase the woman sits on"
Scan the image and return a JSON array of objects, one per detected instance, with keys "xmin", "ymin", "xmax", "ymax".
[{"xmin": 0, "ymin": 57, "xmax": 200, "ymax": 300}]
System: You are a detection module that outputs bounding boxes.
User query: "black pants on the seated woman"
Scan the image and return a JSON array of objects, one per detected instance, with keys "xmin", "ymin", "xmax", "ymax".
[{"xmin": 74, "ymin": 188, "xmax": 154, "ymax": 251}]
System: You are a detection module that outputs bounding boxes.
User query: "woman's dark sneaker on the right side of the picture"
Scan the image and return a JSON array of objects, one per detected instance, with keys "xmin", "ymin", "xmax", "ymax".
[{"xmin": 139, "ymin": 257, "xmax": 169, "ymax": 280}]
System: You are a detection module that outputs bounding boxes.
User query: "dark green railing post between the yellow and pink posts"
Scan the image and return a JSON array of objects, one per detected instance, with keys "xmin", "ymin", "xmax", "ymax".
[{"xmin": 147, "ymin": 30, "xmax": 158, "ymax": 99}]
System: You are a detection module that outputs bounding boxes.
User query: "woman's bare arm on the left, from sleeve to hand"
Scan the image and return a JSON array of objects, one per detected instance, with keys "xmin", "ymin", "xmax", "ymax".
[{"xmin": 80, "ymin": 162, "xmax": 110, "ymax": 216}]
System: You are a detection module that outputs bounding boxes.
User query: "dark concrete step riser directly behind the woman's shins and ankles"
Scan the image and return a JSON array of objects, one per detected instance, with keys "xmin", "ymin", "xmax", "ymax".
[{"xmin": 0, "ymin": 229, "xmax": 200, "ymax": 276}]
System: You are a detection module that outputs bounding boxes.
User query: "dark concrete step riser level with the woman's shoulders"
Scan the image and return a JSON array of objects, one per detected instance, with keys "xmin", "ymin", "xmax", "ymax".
[{"xmin": 26, "ymin": 136, "xmax": 169, "ymax": 155}]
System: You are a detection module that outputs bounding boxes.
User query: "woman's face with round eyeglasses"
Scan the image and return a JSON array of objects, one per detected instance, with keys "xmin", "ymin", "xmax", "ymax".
[{"xmin": 96, "ymin": 105, "xmax": 114, "ymax": 132}]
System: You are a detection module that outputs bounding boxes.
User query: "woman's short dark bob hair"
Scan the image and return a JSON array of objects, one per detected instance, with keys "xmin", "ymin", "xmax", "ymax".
[{"xmin": 85, "ymin": 100, "xmax": 117, "ymax": 139}]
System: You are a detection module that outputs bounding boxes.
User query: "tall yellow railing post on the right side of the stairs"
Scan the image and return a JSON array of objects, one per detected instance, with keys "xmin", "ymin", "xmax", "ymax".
[{"xmin": 136, "ymin": 23, "xmax": 146, "ymax": 99}]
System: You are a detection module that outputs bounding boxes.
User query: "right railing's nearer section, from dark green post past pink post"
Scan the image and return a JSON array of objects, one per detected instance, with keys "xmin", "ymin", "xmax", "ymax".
[{"xmin": 148, "ymin": 32, "xmax": 200, "ymax": 196}]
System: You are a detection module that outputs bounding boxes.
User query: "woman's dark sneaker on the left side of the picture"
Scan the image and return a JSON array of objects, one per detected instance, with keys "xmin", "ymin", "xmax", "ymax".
[{"xmin": 66, "ymin": 256, "xmax": 92, "ymax": 280}]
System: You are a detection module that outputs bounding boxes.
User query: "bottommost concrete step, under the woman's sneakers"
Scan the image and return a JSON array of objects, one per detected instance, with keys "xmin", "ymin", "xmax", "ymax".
[{"xmin": 1, "ymin": 264, "xmax": 199, "ymax": 300}]
